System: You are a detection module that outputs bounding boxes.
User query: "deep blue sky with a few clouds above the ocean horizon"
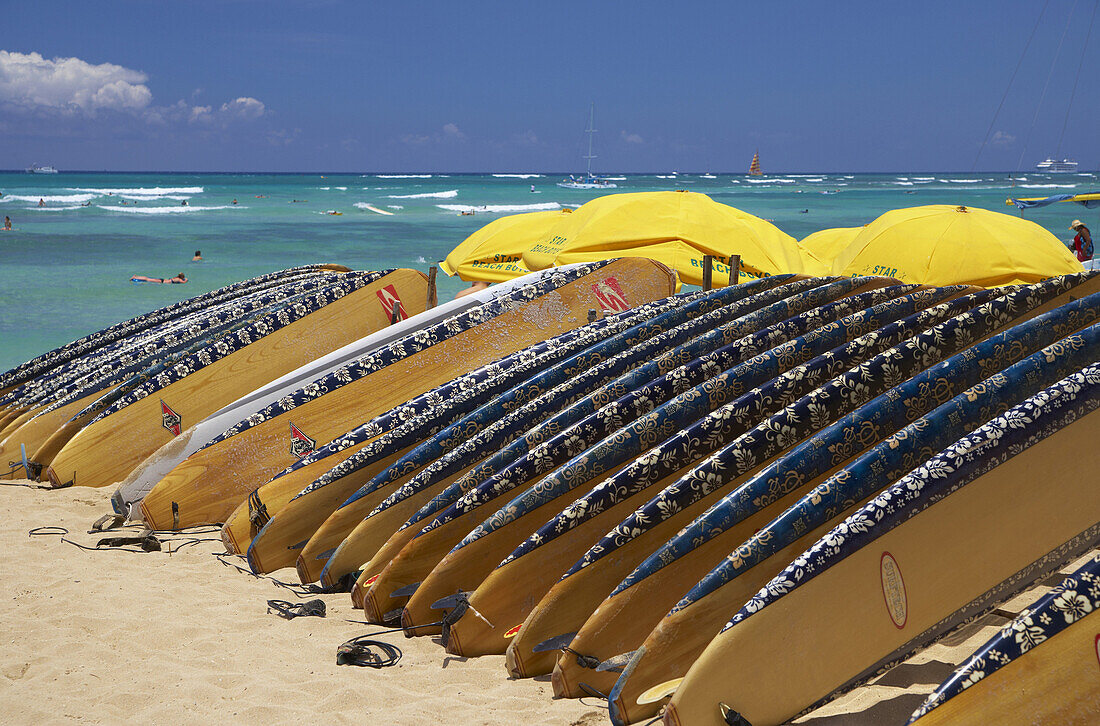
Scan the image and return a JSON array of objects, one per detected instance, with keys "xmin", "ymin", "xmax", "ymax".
[{"xmin": 0, "ymin": 0, "xmax": 1100, "ymax": 172}]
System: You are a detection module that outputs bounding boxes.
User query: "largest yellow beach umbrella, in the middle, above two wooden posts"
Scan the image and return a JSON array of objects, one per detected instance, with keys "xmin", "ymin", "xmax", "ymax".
[{"xmin": 524, "ymin": 191, "xmax": 802, "ymax": 285}]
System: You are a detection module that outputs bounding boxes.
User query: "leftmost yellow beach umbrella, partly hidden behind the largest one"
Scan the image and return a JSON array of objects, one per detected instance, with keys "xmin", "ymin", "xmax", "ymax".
[{"xmin": 439, "ymin": 209, "xmax": 572, "ymax": 283}]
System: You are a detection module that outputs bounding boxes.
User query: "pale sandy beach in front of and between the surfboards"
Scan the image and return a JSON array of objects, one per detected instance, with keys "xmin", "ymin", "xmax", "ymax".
[{"xmin": 0, "ymin": 481, "xmax": 1091, "ymax": 726}]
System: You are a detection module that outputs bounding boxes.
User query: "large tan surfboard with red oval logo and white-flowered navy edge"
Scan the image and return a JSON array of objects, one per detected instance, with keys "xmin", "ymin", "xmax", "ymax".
[{"xmin": 666, "ymin": 360, "xmax": 1100, "ymax": 725}]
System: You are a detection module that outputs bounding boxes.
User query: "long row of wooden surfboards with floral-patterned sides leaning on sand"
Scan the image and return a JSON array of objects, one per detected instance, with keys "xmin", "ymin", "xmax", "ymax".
[{"xmin": 0, "ymin": 259, "xmax": 1100, "ymax": 726}]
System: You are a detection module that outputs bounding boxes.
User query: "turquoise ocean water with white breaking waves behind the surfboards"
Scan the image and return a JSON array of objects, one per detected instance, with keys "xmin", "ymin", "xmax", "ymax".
[{"xmin": 0, "ymin": 172, "xmax": 1100, "ymax": 371}]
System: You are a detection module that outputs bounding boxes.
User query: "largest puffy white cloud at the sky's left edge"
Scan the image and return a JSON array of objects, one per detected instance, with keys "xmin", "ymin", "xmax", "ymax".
[{"xmin": 0, "ymin": 51, "xmax": 153, "ymax": 114}]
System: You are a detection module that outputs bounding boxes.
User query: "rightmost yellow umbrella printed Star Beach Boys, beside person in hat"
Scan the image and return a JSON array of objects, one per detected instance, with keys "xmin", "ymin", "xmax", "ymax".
[{"xmin": 833, "ymin": 205, "xmax": 1082, "ymax": 287}]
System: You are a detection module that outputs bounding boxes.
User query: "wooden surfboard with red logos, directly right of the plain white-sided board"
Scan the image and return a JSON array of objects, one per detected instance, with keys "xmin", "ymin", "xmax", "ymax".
[{"xmin": 142, "ymin": 257, "xmax": 674, "ymax": 528}]
